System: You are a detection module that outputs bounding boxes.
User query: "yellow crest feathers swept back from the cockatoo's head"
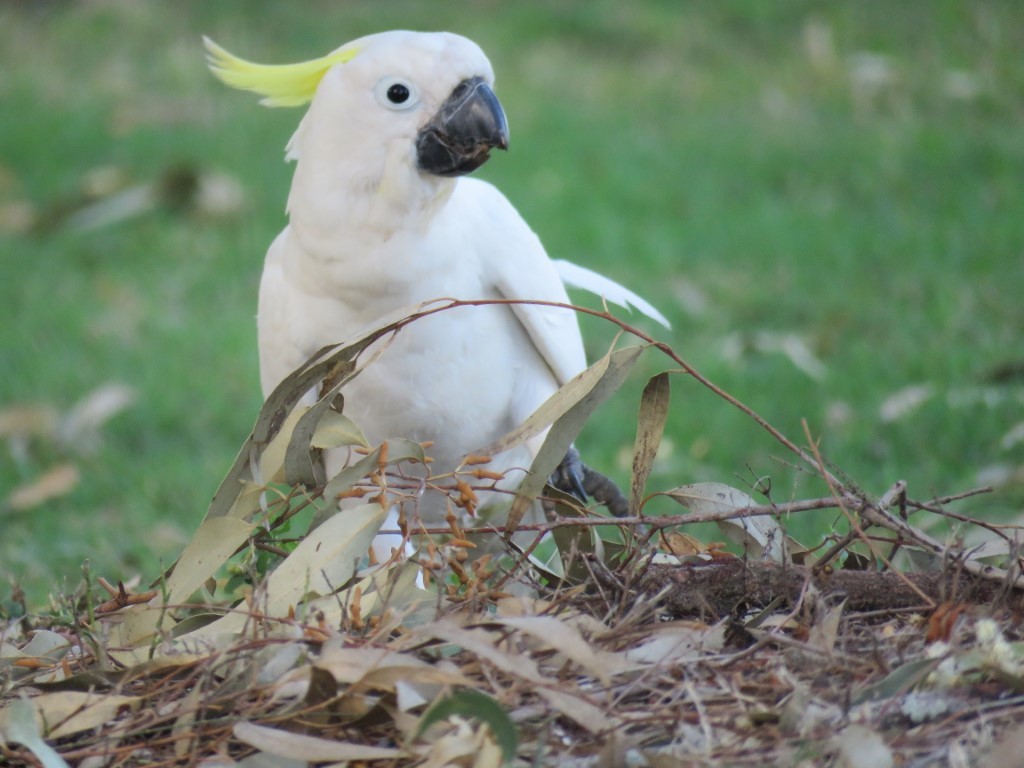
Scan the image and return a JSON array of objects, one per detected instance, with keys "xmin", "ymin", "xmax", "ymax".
[{"xmin": 203, "ymin": 37, "xmax": 359, "ymax": 106}]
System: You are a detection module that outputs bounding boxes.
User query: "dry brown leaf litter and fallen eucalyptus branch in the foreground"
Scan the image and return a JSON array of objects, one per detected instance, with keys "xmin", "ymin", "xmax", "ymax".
[{"xmin": 0, "ymin": 301, "xmax": 1024, "ymax": 768}]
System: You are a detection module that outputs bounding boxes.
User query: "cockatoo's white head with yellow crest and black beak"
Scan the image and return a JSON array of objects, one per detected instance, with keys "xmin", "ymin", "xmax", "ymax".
[{"xmin": 205, "ymin": 31, "xmax": 509, "ymax": 180}]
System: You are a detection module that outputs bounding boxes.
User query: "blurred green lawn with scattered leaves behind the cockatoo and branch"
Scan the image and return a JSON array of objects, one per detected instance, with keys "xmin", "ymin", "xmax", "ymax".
[{"xmin": 0, "ymin": 0, "xmax": 1024, "ymax": 603}]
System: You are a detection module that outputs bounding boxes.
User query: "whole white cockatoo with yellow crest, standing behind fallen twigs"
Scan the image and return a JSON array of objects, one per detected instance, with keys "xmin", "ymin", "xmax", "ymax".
[{"xmin": 206, "ymin": 32, "xmax": 665, "ymax": 536}]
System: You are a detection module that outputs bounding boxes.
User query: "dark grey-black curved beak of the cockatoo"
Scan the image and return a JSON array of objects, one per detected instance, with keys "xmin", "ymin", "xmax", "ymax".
[{"xmin": 416, "ymin": 78, "xmax": 509, "ymax": 176}]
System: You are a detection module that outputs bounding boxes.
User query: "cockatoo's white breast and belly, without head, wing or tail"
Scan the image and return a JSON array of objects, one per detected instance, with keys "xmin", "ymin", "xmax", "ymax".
[{"xmin": 260, "ymin": 179, "xmax": 557, "ymax": 493}]
